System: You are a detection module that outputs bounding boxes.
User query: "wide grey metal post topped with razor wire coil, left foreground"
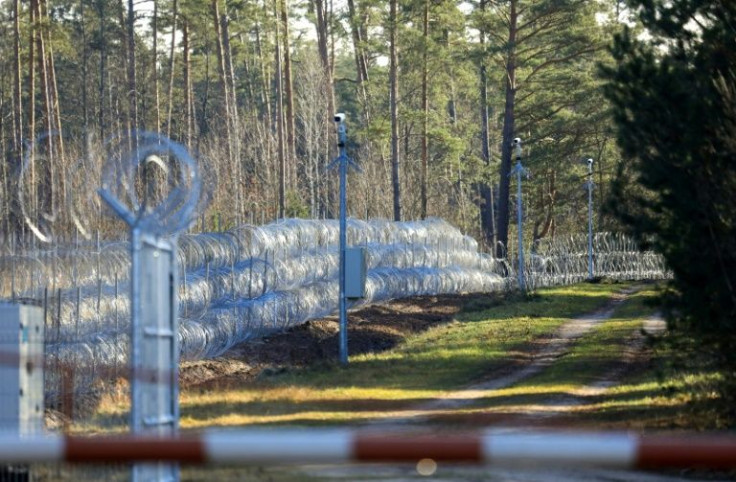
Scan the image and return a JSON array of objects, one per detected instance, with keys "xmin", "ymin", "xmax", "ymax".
[{"xmin": 98, "ymin": 133, "xmax": 201, "ymax": 482}]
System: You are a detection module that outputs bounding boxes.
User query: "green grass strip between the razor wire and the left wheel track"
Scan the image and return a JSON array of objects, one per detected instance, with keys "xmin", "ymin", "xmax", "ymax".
[{"xmin": 175, "ymin": 284, "xmax": 626, "ymax": 428}]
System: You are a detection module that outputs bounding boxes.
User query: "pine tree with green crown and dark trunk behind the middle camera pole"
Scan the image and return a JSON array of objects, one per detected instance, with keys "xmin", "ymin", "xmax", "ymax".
[{"xmin": 480, "ymin": 0, "xmax": 602, "ymax": 256}]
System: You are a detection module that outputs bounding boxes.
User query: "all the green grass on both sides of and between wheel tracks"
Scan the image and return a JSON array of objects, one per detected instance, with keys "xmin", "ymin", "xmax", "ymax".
[{"xmin": 85, "ymin": 284, "xmax": 732, "ymax": 431}]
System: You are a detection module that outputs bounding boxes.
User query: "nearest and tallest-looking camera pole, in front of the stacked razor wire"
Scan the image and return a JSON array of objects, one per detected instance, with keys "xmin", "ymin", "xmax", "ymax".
[{"xmin": 329, "ymin": 114, "xmax": 358, "ymax": 365}]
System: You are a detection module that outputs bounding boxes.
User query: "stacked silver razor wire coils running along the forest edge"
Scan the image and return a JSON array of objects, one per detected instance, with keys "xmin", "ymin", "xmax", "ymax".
[{"xmin": 0, "ymin": 219, "xmax": 670, "ymax": 410}]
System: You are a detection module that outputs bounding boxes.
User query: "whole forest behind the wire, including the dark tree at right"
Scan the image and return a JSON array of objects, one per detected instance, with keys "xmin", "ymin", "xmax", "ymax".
[{"xmin": 0, "ymin": 0, "xmax": 736, "ymax": 418}]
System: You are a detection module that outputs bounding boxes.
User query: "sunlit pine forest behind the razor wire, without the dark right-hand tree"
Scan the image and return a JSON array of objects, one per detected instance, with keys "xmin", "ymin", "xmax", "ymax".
[{"xmin": 0, "ymin": 0, "xmax": 636, "ymax": 254}]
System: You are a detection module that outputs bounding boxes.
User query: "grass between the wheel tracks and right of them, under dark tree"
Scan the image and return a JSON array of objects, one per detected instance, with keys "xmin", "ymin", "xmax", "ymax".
[{"xmin": 468, "ymin": 287, "xmax": 733, "ymax": 430}]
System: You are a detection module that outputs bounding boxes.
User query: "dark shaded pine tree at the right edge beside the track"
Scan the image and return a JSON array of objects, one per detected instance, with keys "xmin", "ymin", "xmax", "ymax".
[{"xmin": 605, "ymin": 0, "xmax": 736, "ymax": 372}]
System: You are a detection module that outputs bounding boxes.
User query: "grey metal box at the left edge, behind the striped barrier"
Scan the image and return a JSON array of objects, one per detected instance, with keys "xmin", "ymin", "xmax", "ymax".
[{"xmin": 0, "ymin": 303, "xmax": 44, "ymax": 435}]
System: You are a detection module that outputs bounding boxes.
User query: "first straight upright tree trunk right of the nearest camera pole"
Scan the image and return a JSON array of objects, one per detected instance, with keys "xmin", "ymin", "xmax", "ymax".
[{"xmin": 389, "ymin": 0, "xmax": 401, "ymax": 221}]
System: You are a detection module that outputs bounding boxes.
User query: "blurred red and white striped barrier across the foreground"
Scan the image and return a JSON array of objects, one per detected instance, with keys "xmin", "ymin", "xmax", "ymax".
[{"xmin": 0, "ymin": 429, "xmax": 736, "ymax": 469}]
